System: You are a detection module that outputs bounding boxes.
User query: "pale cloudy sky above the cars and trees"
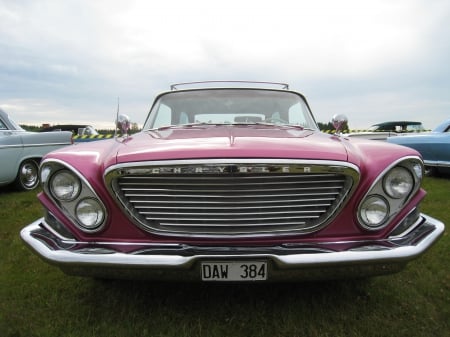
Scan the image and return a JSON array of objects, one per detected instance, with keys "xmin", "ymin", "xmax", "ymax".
[{"xmin": 0, "ymin": 0, "xmax": 450, "ymax": 128}]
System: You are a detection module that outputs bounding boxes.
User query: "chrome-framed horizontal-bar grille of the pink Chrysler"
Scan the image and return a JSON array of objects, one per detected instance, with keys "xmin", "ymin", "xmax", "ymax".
[{"xmin": 106, "ymin": 161, "xmax": 358, "ymax": 237}]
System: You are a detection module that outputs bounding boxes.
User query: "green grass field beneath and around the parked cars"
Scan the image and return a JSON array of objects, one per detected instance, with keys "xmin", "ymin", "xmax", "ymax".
[{"xmin": 0, "ymin": 177, "xmax": 450, "ymax": 337}]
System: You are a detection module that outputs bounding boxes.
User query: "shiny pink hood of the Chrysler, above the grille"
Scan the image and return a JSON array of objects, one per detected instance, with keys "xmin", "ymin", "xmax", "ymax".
[{"xmin": 116, "ymin": 125, "xmax": 348, "ymax": 163}]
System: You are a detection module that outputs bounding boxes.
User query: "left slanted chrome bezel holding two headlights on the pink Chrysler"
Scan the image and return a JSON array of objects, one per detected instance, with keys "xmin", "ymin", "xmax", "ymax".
[{"xmin": 40, "ymin": 159, "xmax": 107, "ymax": 233}]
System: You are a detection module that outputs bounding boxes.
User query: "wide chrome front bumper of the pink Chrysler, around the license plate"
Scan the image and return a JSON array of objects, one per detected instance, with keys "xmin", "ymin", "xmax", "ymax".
[{"xmin": 20, "ymin": 214, "xmax": 444, "ymax": 282}]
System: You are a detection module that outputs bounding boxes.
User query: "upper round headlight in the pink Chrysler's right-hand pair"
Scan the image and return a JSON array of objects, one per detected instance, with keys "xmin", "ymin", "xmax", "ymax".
[{"xmin": 383, "ymin": 166, "xmax": 414, "ymax": 199}]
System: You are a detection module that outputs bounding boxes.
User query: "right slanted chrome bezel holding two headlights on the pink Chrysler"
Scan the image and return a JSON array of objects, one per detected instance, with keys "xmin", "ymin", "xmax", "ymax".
[{"xmin": 357, "ymin": 156, "xmax": 423, "ymax": 231}]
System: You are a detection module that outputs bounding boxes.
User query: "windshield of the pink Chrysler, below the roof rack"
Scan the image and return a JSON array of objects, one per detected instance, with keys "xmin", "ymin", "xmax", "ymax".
[{"xmin": 144, "ymin": 89, "xmax": 317, "ymax": 129}]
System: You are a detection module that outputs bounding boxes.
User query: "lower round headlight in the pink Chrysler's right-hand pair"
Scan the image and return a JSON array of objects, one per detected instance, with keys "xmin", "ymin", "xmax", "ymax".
[{"xmin": 359, "ymin": 195, "xmax": 389, "ymax": 230}]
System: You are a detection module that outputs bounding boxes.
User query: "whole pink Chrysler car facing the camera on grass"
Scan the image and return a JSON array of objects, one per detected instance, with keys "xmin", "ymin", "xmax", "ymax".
[{"xmin": 21, "ymin": 82, "xmax": 444, "ymax": 282}]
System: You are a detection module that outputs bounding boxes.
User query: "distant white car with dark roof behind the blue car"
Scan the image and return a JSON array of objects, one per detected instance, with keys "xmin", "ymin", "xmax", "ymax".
[{"xmin": 345, "ymin": 121, "xmax": 425, "ymax": 140}]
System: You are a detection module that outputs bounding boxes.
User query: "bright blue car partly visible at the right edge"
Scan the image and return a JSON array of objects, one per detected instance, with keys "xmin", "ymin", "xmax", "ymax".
[{"xmin": 387, "ymin": 119, "xmax": 450, "ymax": 175}]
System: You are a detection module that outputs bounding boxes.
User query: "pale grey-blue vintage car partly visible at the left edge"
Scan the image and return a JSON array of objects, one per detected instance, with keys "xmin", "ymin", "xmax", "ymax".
[{"xmin": 0, "ymin": 109, "xmax": 72, "ymax": 190}]
